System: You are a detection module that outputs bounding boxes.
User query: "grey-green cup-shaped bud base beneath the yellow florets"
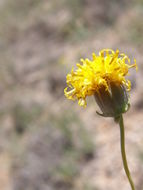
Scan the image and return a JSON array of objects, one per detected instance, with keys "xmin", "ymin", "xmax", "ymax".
[{"xmin": 94, "ymin": 83, "xmax": 129, "ymax": 118}]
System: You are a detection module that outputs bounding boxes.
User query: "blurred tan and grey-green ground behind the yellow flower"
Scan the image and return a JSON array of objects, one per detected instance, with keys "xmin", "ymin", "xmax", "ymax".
[{"xmin": 0, "ymin": 0, "xmax": 143, "ymax": 190}]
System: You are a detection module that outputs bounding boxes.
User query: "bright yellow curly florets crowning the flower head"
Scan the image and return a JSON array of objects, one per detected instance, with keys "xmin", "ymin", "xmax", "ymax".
[{"xmin": 64, "ymin": 49, "xmax": 137, "ymax": 106}]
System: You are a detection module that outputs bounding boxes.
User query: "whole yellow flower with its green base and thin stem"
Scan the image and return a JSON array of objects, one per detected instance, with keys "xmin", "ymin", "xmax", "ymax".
[{"xmin": 64, "ymin": 49, "xmax": 137, "ymax": 190}]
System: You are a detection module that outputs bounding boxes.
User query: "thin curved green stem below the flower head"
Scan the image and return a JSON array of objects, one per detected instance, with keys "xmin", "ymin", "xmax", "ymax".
[{"xmin": 119, "ymin": 115, "xmax": 135, "ymax": 190}]
